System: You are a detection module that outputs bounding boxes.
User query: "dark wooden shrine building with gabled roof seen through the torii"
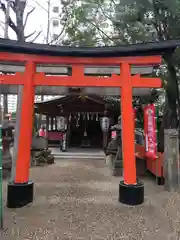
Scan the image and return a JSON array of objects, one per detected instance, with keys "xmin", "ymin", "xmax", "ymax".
[{"xmin": 35, "ymin": 94, "xmax": 119, "ymax": 148}]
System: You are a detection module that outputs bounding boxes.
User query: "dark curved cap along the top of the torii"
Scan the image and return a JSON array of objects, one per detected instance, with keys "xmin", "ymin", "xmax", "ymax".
[{"xmin": 0, "ymin": 38, "xmax": 180, "ymax": 57}]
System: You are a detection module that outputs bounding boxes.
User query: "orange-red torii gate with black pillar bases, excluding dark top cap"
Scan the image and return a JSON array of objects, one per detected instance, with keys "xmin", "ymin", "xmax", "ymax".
[{"xmin": 0, "ymin": 40, "xmax": 168, "ymax": 208}]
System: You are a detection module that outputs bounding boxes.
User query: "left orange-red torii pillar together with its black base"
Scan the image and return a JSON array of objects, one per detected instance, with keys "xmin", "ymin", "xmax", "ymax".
[{"xmin": 7, "ymin": 62, "xmax": 36, "ymax": 208}]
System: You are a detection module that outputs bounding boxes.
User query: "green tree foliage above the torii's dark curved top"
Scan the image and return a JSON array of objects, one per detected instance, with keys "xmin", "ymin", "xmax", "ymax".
[{"xmin": 62, "ymin": 0, "xmax": 180, "ymax": 46}]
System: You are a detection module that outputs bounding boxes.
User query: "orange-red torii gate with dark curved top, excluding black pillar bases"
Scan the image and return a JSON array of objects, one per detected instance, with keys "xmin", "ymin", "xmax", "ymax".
[{"xmin": 0, "ymin": 39, "xmax": 180, "ymax": 193}]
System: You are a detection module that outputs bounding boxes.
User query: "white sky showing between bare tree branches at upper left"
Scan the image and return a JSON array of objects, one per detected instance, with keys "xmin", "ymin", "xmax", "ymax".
[{"xmin": 0, "ymin": 0, "xmax": 60, "ymax": 43}]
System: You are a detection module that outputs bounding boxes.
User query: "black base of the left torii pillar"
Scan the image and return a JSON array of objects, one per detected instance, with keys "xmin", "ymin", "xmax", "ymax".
[{"xmin": 7, "ymin": 182, "xmax": 34, "ymax": 208}]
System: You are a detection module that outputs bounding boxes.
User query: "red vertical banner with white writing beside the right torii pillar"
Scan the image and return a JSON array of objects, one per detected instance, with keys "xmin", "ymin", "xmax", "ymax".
[{"xmin": 144, "ymin": 104, "xmax": 157, "ymax": 159}]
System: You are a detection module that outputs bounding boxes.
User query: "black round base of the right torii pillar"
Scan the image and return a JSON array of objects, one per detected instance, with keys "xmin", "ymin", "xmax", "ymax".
[{"xmin": 119, "ymin": 181, "xmax": 144, "ymax": 206}]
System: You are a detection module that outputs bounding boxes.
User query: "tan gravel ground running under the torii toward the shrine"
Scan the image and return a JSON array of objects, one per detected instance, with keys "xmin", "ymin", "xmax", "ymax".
[{"xmin": 0, "ymin": 160, "xmax": 180, "ymax": 240}]
